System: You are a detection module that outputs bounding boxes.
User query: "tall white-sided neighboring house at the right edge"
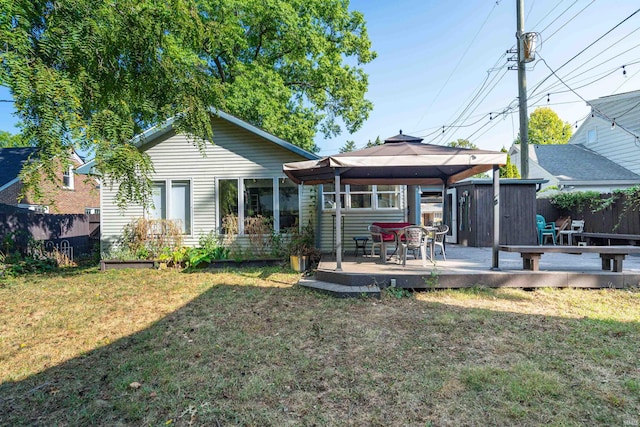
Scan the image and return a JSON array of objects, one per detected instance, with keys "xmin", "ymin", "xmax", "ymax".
[{"xmin": 569, "ymin": 91, "xmax": 640, "ymax": 174}]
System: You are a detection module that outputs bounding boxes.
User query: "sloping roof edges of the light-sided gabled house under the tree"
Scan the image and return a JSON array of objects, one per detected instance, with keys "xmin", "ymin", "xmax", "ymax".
[{"xmin": 76, "ymin": 107, "xmax": 320, "ymax": 174}]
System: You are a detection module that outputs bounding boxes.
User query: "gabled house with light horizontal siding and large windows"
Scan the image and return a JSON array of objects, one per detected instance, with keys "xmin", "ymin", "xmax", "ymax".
[{"xmin": 81, "ymin": 110, "xmax": 317, "ymax": 254}]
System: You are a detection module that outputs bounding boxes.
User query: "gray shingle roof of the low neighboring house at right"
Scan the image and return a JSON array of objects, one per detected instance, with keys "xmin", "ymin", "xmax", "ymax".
[{"xmin": 534, "ymin": 144, "xmax": 640, "ymax": 182}]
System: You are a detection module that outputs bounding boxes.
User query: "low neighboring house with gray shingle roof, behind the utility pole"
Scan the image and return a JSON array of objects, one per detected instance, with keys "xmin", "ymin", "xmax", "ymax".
[{"xmin": 509, "ymin": 144, "xmax": 640, "ymax": 193}]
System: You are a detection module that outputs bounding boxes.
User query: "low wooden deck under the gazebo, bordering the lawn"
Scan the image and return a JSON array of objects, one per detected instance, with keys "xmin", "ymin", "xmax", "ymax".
[{"xmin": 301, "ymin": 244, "xmax": 640, "ymax": 296}]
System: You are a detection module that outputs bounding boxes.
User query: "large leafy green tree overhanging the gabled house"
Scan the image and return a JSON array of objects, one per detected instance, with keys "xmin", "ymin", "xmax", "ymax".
[{"xmin": 0, "ymin": 0, "xmax": 375, "ymax": 205}]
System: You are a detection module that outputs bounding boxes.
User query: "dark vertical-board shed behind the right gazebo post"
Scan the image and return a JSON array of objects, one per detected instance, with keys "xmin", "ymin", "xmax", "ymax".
[{"xmin": 446, "ymin": 178, "xmax": 546, "ymax": 247}]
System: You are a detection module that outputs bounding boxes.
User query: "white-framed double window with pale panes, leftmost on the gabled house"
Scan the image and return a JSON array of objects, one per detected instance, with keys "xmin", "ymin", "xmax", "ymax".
[{"xmin": 149, "ymin": 180, "xmax": 191, "ymax": 234}]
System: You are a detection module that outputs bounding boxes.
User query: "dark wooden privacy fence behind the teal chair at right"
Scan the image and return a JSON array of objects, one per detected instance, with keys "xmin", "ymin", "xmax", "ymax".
[{"xmin": 537, "ymin": 194, "xmax": 640, "ymax": 234}]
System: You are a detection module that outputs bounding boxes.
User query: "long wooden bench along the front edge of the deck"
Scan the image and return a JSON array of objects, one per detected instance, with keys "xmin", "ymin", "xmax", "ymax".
[{"xmin": 500, "ymin": 245, "xmax": 640, "ymax": 273}]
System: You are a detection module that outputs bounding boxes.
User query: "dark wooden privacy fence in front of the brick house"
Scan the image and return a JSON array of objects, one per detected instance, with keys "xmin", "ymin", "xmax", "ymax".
[{"xmin": 0, "ymin": 212, "xmax": 100, "ymax": 257}]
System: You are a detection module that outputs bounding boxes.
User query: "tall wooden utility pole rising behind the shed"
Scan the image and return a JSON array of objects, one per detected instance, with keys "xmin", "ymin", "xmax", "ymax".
[{"xmin": 516, "ymin": 0, "xmax": 529, "ymax": 179}]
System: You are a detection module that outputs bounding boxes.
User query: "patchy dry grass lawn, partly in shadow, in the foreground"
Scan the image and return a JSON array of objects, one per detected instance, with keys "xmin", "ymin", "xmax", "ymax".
[{"xmin": 0, "ymin": 269, "xmax": 640, "ymax": 426}]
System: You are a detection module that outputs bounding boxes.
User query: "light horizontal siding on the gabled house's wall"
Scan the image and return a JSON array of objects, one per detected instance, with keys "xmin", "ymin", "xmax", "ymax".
[{"xmin": 101, "ymin": 118, "xmax": 314, "ymax": 252}]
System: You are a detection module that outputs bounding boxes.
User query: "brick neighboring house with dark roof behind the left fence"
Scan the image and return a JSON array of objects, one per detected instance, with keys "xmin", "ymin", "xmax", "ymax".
[{"xmin": 0, "ymin": 147, "xmax": 100, "ymax": 214}]
